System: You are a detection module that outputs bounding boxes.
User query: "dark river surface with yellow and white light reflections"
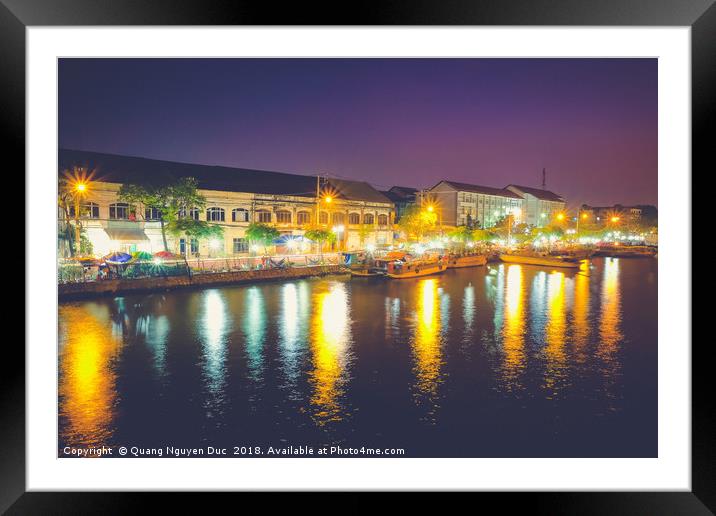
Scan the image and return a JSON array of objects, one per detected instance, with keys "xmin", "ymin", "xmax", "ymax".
[{"xmin": 59, "ymin": 258, "xmax": 657, "ymax": 457}]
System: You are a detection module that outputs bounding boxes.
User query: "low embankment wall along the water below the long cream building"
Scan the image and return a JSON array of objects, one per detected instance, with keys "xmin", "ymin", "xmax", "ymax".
[{"xmin": 57, "ymin": 265, "xmax": 346, "ymax": 301}]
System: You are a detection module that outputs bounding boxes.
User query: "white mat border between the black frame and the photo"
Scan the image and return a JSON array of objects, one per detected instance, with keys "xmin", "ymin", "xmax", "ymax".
[{"xmin": 26, "ymin": 27, "xmax": 691, "ymax": 491}]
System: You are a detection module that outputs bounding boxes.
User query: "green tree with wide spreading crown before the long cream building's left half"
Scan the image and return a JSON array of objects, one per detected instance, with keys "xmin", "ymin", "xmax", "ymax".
[{"xmin": 118, "ymin": 177, "xmax": 206, "ymax": 251}]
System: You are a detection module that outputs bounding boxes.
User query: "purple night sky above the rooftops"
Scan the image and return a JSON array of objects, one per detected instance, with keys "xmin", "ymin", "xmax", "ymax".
[{"xmin": 59, "ymin": 59, "xmax": 657, "ymax": 207}]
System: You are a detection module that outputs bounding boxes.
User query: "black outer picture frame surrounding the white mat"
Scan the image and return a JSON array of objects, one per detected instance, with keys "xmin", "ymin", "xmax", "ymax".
[{"xmin": 0, "ymin": 0, "xmax": 716, "ymax": 514}]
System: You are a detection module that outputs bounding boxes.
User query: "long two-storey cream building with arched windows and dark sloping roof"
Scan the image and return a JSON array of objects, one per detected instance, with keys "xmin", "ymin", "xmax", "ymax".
[{"xmin": 58, "ymin": 149, "xmax": 394, "ymax": 257}]
